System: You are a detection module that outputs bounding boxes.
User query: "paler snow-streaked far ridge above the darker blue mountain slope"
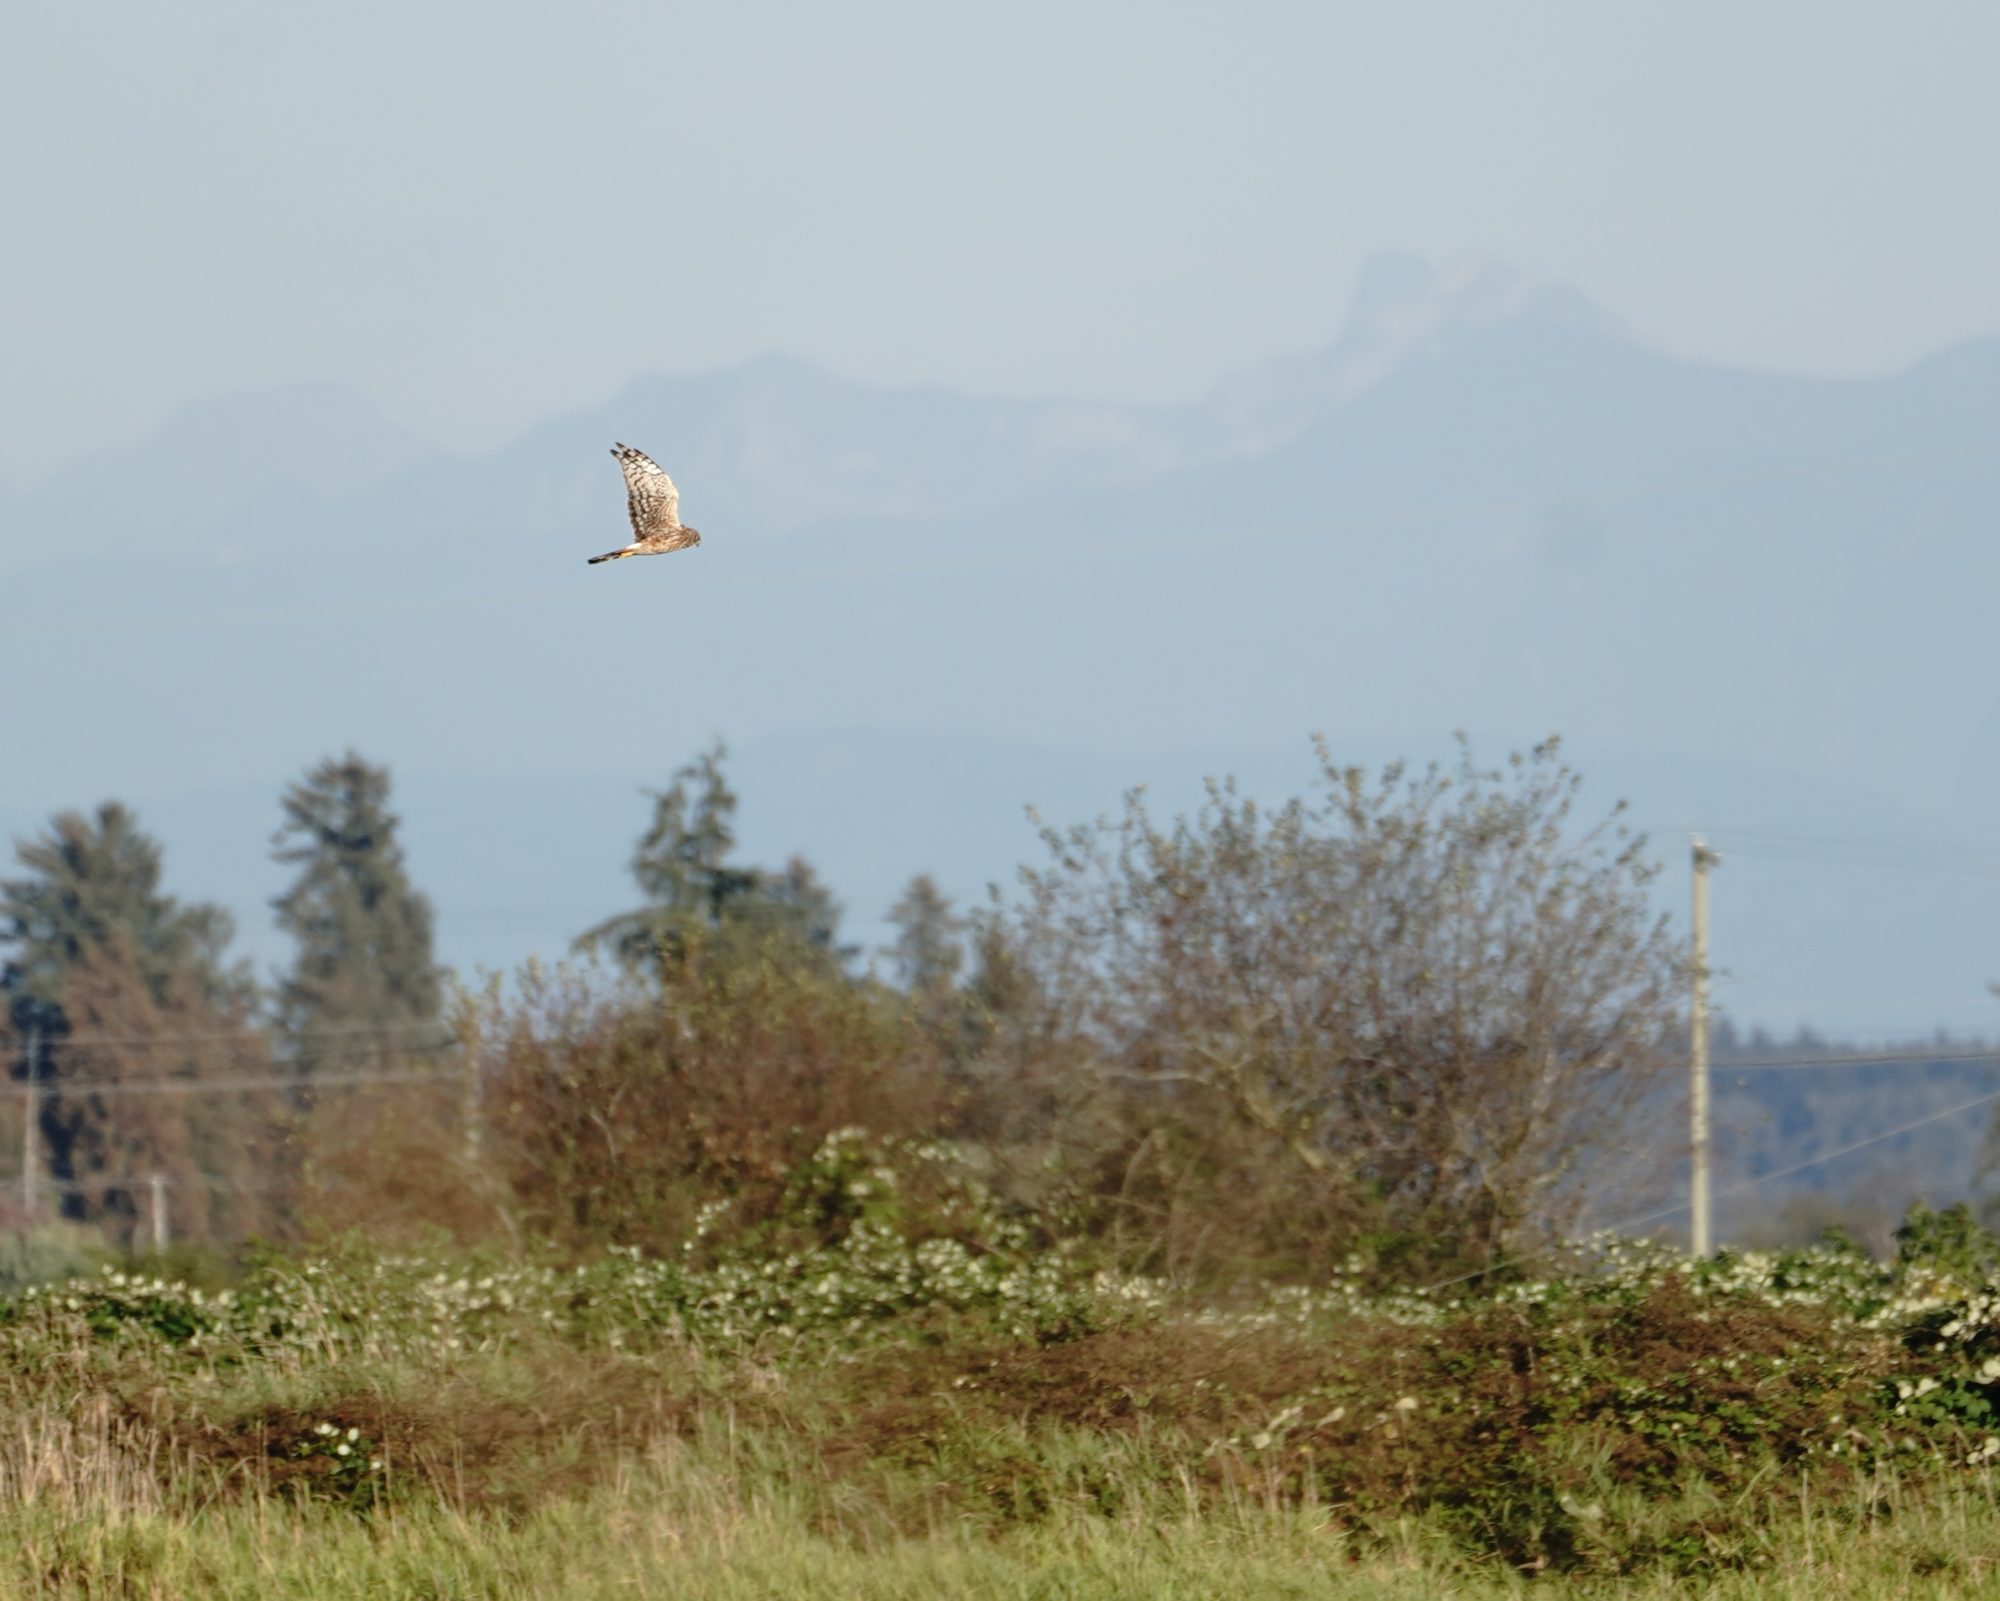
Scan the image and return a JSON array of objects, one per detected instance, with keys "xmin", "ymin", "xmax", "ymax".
[{"xmin": 0, "ymin": 256, "xmax": 1648, "ymax": 572}]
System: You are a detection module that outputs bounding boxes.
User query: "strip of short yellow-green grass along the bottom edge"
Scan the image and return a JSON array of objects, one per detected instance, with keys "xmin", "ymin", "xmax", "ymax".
[{"xmin": 11, "ymin": 1465, "xmax": 2000, "ymax": 1601}]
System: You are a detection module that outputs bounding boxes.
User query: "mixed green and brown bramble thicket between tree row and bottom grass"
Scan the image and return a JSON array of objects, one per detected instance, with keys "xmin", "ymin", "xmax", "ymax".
[{"xmin": 0, "ymin": 1184, "xmax": 2000, "ymax": 1583}]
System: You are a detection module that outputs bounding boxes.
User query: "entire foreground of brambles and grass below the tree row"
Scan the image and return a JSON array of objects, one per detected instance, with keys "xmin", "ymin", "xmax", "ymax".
[{"xmin": 0, "ymin": 1153, "xmax": 2000, "ymax": 1597}]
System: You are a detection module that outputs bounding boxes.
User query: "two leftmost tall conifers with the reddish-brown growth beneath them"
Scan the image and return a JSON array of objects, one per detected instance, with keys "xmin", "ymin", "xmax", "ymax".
[{"xmin": 0, "ymin": 752, "xmax": 444, "ymax": 1239}]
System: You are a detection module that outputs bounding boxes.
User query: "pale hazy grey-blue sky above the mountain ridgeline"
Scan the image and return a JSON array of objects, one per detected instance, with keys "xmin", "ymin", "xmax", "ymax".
[{"xmin": 0, "ymin": 0, "xmax": 2000, "ymax": 482}]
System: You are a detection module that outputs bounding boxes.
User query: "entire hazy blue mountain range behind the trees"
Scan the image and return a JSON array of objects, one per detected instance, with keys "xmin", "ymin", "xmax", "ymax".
[{"xmin": 0, "ymin": 258, "xmax": 2000, "ymax": 1064}]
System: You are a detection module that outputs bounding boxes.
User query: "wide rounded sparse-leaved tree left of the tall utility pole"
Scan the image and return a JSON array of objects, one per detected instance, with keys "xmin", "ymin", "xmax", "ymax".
[{"xmin": 1012, "ymin": 740, "xmax": 1684, "ymax": 1265}]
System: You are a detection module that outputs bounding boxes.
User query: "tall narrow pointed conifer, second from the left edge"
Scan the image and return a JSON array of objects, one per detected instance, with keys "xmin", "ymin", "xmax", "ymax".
[{"xmin": 272, "ymin": 750, "xmax": 442, "ymax": 1057}]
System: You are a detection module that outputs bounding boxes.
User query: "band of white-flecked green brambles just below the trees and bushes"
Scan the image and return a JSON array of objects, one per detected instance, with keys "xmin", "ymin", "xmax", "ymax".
[{"xmin": 19, "ymin": 1160, "xmax": 2000, "ymax": 1496}]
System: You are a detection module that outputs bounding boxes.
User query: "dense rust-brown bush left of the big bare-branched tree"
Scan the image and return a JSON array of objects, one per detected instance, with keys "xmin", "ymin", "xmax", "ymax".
[{"xmin": 472, "ymin": 939, "xmax": 944, "ymax": 1251}]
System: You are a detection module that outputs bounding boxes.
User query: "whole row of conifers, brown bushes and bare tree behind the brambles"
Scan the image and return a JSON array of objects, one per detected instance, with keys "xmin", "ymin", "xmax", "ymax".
[{"xmin": 0, "ymin": 742, "xmax": 1686, "ymax": 1279}]
